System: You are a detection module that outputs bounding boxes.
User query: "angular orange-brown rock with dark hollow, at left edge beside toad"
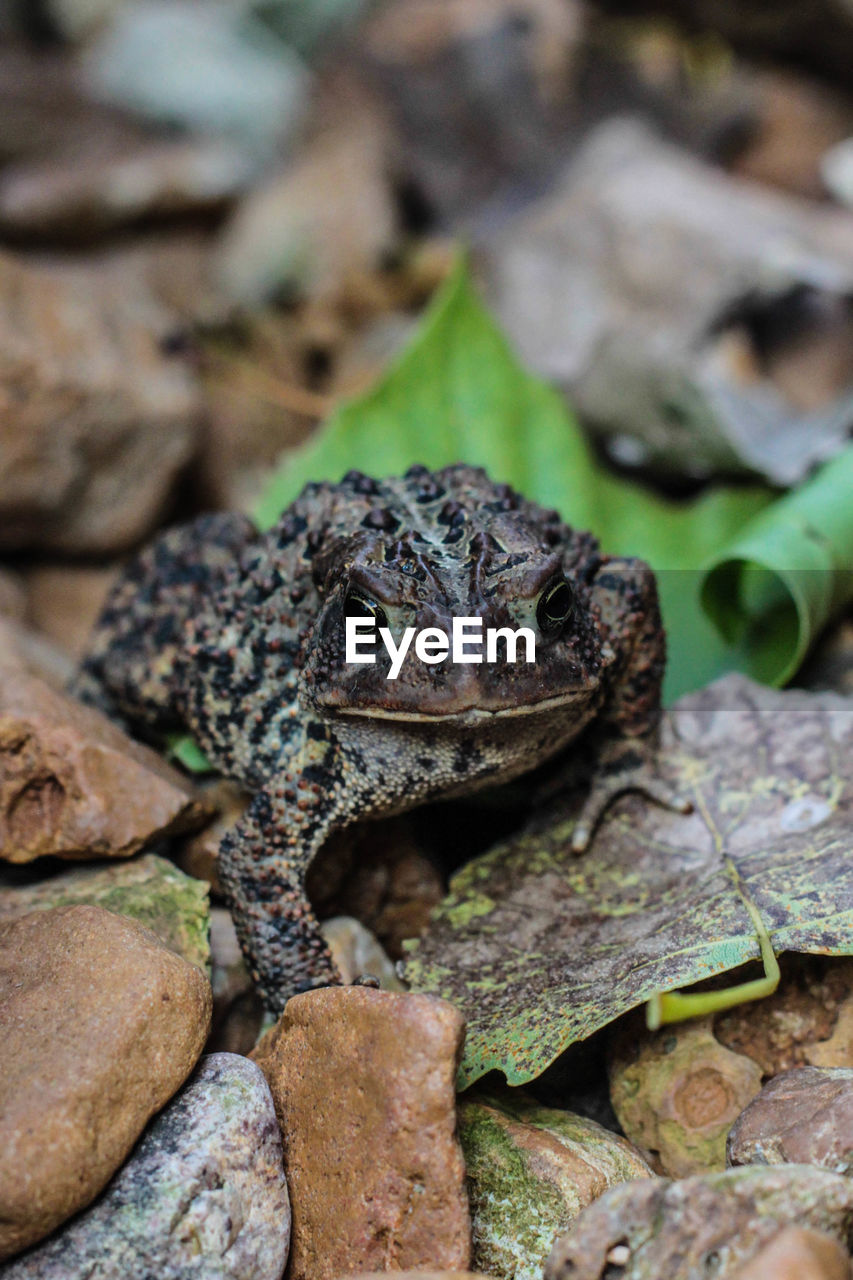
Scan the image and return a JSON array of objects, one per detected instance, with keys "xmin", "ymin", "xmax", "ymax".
[{"xmin": 0, "ymin": 664, "xmax": 205, "ymax": 863}]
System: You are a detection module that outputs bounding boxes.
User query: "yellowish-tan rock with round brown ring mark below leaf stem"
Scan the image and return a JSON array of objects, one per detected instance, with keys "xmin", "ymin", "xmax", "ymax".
[{"xmin": 608, "ymin": 1016, "xmax": 761, "ymax": 1178}]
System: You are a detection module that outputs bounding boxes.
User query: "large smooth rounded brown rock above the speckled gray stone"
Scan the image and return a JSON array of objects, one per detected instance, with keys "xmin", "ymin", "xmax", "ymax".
[{"xmin": 0, "ymin": 906, "xmax": 211, "ymax": 1258}]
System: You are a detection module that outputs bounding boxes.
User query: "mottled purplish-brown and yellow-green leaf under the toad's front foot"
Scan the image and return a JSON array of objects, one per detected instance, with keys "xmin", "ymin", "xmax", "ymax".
[{"xmin": 405, "ymin": 675, "xmax": 853, "ymax": 1088}]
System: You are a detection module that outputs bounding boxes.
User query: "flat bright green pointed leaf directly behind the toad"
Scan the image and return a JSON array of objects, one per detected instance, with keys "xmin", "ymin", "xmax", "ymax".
[{"xmin": 252, "ymin": 262, "xmax": 772, "ymax": 698}]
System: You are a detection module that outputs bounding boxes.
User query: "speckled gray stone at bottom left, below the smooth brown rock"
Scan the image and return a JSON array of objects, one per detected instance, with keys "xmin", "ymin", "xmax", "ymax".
[{"xmin": 1, "ymin": 1053, "xmax": 291, "ymax": 1280}]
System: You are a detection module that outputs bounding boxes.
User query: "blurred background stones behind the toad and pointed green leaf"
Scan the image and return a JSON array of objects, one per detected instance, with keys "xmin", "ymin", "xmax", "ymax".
[{"xmin": 0, "ymin": 0, "xmax": 853, "ymax": 678}]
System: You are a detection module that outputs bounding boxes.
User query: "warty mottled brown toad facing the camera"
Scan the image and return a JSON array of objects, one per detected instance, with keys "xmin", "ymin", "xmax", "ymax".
[{"xmin": 76, "ymin": 466, "xmax": 680, "ymax": 1010}]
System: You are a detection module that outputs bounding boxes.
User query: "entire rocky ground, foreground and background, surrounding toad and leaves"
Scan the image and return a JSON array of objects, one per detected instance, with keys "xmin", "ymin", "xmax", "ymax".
[{"xmin": 0, "ymin": 0, "xmax": 853, "ymax": 1280}]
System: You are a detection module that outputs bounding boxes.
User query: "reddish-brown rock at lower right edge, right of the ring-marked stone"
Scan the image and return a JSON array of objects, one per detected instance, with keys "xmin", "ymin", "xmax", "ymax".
[{"xmin": 727, "ymin": 1066, "xmax": 853, "ymax": 1174}]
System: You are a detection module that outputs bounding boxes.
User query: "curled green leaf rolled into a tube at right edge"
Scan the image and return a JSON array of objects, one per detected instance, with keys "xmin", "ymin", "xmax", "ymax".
[{"xmin": 702, "ymin": 445, "xmax": 853, "ymax": 685}]
